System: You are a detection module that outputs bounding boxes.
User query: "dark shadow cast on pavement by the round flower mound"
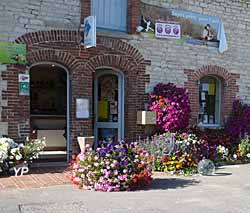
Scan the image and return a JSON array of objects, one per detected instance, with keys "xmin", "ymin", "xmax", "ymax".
[{"xmin": 149, "ymin": 178, "xmax": 200, "ymax": 190}]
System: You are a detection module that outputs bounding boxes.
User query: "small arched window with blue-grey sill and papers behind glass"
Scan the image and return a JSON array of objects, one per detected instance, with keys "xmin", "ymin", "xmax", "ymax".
[{"xmin": 199, "ymin": 76, "xmax": 221, "ymax": 127}]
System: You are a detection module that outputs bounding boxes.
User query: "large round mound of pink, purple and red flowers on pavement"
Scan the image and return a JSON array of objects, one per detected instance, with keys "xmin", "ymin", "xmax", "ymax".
[{"xmin": 71, "ymin": 142, "xmax": 152, "ymax": 192}]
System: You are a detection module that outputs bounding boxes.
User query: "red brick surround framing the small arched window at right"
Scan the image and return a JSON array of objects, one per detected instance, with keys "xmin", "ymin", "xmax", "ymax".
[{"xmin": 184, "ymin": 65, "xmax": 240, "ymax": 125}]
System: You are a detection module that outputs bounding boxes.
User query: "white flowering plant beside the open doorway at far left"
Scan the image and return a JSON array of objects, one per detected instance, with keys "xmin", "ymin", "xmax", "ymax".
[{"xmin": 0, "ymin": 138, "xmax": 45, "ymax": 173}]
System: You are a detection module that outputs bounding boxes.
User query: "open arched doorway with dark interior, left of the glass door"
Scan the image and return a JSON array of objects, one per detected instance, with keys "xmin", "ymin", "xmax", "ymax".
[{"xmin": 30, "ymin": 63, "xmax": 69, "ymax": 162}]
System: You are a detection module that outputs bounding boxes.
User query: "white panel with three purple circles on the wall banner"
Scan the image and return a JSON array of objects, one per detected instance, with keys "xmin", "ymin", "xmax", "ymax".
[{"xmin": 155, "ymin": 23, "xmax": 181, "ymax": 39}]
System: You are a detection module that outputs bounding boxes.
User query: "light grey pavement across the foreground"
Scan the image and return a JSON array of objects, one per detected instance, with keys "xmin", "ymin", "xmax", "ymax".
[{"xmin": 0, "ymin": 164, "xmax": 250, "ymax": 213}]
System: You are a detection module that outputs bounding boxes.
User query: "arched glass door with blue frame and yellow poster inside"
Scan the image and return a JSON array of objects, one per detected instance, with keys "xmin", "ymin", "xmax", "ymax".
[{"xmin": 95, "ymin": 70, "xmax": 124, "ymax": 146}]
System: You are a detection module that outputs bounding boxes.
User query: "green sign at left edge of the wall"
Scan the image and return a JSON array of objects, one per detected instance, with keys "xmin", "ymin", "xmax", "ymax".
[{"xmin": 0, "ymin": 41, "xmax": 27, "ymax": 65}]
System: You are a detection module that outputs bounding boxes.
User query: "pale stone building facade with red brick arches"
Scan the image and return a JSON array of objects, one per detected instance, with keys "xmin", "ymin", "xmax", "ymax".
[{"xmin": 0, "ymin": 0, "xmax": 250, "ymax": 160}]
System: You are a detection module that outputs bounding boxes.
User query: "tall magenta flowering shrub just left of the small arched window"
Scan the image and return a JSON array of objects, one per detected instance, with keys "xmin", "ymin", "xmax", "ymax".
[{"xmin": 149, "ymin": 83, "xmax": 190, "ymax": 132}]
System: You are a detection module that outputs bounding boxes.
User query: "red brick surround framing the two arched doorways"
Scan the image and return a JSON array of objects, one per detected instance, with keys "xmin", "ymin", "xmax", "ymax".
[{"xmin": 9, "ymin": 31, "xmax": 150, "ymax": 153}]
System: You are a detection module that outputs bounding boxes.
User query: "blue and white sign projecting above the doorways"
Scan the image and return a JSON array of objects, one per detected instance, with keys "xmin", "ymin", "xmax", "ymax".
[{"xmin": 83, "ymin": 16, "xmax": 96, "ymax": 48}]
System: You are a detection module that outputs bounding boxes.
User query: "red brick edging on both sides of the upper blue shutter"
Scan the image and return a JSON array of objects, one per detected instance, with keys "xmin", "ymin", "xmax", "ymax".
[{"xmin": 81, "ymin": 0, "xmax": 141, "ymax": 34}]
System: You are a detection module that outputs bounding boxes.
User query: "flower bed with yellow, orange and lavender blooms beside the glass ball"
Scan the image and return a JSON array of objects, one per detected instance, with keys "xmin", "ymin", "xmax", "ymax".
[{"xmin": 141, "ymin": 132, "xmax": 199, "ymax": 175}]
